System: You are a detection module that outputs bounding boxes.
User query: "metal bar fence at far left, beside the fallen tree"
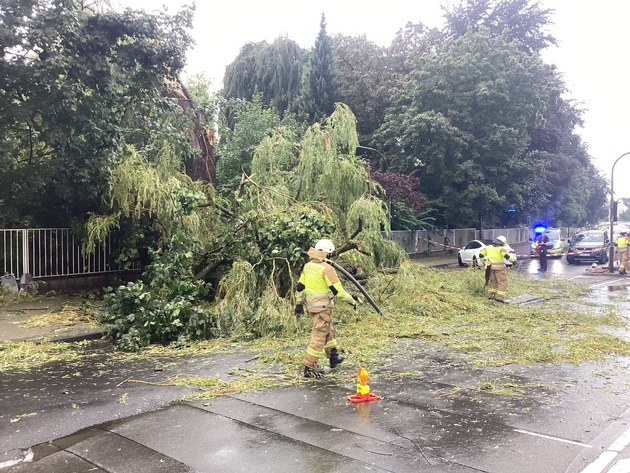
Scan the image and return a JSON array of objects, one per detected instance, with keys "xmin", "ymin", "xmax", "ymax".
[{"xmin": 0, "ymin": 228, "xmax": 128, "ymax": 278}]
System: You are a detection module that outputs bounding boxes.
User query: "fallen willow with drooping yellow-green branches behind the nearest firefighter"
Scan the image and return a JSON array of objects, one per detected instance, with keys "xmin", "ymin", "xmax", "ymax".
[{"xmin": 96, "ymin": 104, "xmax": 404, "ymax": 349}]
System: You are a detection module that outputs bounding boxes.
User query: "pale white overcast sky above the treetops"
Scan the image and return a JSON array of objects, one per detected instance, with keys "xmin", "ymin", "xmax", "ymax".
[{"xmin": 114, "ymin": 0, "xmax": 630, "ymax": 198}]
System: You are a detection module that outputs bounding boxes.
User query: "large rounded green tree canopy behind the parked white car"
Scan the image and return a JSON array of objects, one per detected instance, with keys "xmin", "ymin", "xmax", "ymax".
[{"xmin": 375, "ymin": 31, "xmax": 583, "ymax": 226}]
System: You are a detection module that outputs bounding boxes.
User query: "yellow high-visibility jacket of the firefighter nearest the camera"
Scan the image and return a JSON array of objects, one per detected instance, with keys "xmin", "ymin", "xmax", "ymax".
[{"xmin": 295, "ymin": 248, "xmax": 356, "ymax": 312}]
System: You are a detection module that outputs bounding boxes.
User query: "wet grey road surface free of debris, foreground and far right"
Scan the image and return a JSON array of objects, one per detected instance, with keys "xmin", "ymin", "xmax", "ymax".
[{"xmin": 0, "ymin": 260, "xmax": 630, "ymax": 473}]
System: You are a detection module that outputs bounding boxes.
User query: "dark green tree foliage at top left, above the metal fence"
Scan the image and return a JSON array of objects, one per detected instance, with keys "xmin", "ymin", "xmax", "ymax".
[{"xmin": 0, "ymin": 0, "xmax": 192, "ymax": 226}]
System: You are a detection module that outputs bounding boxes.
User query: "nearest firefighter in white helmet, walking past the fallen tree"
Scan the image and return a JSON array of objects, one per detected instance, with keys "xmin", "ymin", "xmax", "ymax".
[{"xmin": 295, "ymin": 240, "xmax": 358, "ymax": 378}]
